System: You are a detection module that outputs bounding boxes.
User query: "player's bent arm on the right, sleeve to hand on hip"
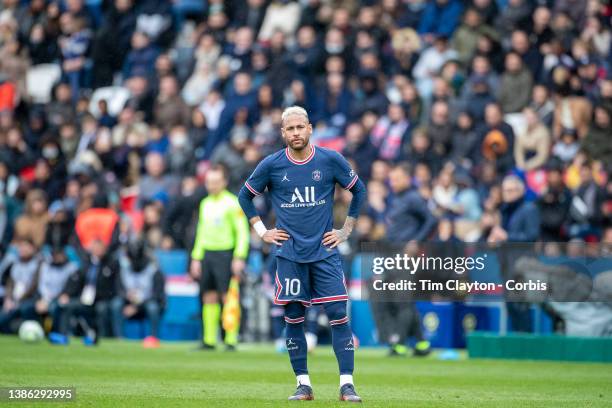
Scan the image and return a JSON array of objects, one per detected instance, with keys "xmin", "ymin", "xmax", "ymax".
[{"xmin": 323, "ymin": 154, "xmax": 366, "ymax": 248}]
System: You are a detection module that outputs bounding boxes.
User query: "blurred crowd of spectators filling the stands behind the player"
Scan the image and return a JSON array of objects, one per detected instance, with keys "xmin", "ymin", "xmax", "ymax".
[{"xmin": 0, "ymin": 0, "xmax": 612, "ymax": 338}]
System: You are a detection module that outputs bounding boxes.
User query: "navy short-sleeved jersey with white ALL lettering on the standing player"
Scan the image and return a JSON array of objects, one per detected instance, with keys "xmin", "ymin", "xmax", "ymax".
[{"xmin": 245, "ymin": 146, "xmax": 358, "ymax": 262}]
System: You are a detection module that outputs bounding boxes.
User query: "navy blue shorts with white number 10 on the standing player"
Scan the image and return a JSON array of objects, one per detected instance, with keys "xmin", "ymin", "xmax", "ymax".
[{"xmin": 274, "ymin": 254, "xmax": 348, "ymax": 306}]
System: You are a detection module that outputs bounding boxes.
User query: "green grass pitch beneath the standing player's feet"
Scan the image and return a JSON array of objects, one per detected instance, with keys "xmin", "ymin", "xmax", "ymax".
[{"xmin": 0, "ymin": 336, "xmax": 612, "ymax": 408}]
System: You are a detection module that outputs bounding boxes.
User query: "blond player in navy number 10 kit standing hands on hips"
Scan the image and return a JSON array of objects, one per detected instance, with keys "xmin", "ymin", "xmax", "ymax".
[{"xmin": 238, "ymin": 106, "xmax": 366, "ymax": 402}]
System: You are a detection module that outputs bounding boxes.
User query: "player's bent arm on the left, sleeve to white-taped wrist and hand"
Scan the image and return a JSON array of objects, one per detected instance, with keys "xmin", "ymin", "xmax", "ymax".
[{"xmin": 238, "ymin": 158, "xmax": 289, "ymax": 245}]
